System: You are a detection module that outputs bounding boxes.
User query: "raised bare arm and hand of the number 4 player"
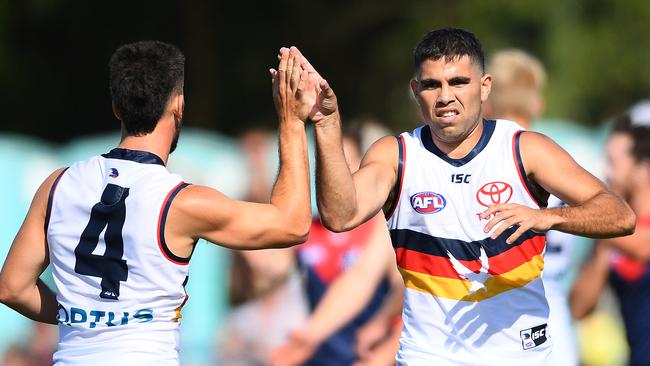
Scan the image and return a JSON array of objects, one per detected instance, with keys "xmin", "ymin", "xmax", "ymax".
[{"xmin": 167, "ymin": 47, "xmax": 314, "ymax": 249}]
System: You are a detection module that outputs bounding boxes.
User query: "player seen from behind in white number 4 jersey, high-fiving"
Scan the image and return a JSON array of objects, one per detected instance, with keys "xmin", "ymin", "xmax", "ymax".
[{"xmin": 0, "ymin": 41, "xmax": 315, "ymax": 366}]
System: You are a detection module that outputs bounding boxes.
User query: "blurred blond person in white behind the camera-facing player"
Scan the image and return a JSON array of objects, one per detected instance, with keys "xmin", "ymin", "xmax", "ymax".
[{"xmin": 485, "ymin": 49, "xmax": 585, "ymax": 365}]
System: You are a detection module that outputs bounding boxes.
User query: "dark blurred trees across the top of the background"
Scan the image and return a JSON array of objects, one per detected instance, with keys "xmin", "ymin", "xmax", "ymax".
[{"xmin": 0, "ymin": 0, "xmax": 650, "ymax": 141}]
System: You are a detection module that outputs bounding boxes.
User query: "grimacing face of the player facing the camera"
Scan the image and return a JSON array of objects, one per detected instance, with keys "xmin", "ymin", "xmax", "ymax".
[{"xmin": 411, "ymin": 56, "xmax": 492, "ymax": 143}]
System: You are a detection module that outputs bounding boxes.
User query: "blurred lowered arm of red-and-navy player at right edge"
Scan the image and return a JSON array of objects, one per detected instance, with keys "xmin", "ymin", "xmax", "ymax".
[{"xmin": 570, "ymin": 243, "xmax": 611, "ymax": 319}]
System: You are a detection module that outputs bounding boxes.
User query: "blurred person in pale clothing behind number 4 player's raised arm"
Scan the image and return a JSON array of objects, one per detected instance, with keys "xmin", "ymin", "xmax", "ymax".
[{"xmin": 216, "ymin": 129, "xmax": 307, "ymax": 366}]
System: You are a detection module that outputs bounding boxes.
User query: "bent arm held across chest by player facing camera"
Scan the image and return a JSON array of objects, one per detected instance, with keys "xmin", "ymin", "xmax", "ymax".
[{"xmin": 483, "ymin": 132, "xmax": 636, "ymax": 243}]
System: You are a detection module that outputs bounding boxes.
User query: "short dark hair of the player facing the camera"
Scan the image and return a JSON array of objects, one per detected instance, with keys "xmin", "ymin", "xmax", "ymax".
[{"xmin": 414, "ymin": 28, "xmax": 485, "ymax": 72}]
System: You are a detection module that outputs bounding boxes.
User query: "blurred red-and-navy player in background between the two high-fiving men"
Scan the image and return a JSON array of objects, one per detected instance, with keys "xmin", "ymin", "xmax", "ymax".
[{"xmin": 271, "ymin": 121, "xmax": 403, "ymax": 365}]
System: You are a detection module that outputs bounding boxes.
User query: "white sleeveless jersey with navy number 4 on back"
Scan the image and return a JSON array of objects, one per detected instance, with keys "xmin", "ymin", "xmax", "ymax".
[{"xmin": 46, "ymin": 149, "xmax": 189, "ymax": 366}]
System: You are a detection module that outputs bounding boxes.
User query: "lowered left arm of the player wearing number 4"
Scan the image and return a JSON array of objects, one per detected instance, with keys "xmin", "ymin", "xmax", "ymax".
[{"xmin": 0, "ymin": 170, "xmax": 62, "ymax": 324}]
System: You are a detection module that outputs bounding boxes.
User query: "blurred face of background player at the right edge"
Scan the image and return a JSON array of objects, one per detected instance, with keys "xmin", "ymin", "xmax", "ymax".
[{"xmin": 605, "ymin": 132, "xmax": 635, "ymax": 199}]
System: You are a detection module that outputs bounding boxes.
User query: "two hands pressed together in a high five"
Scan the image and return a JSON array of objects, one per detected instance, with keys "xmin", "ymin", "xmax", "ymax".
[{"xmin": 269, "ymin": 47, "xmax": 338, "ymax": 124}]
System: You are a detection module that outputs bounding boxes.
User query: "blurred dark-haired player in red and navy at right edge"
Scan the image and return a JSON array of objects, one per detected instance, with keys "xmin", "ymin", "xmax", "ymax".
[{"xmin": 571, "ymin": 101, "xmax": 650, "ymax": 365}]
